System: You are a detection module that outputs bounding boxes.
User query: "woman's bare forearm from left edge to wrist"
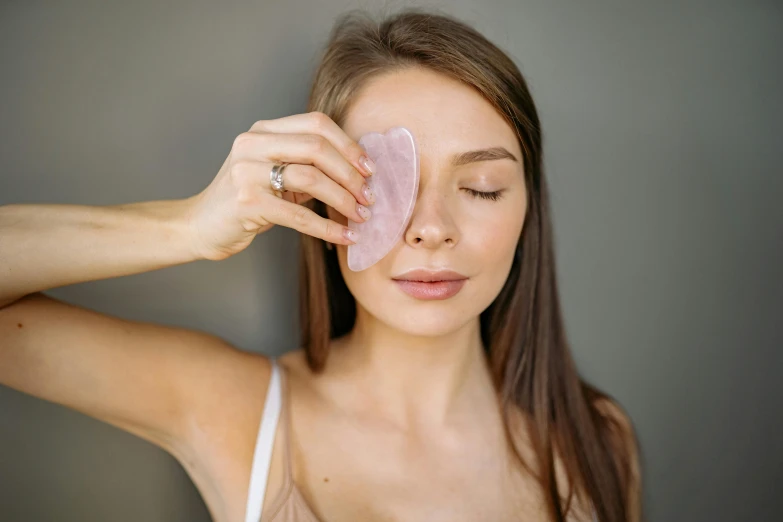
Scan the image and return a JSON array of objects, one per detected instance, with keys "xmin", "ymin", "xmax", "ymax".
[{"xmin": 0, "ymin": 199, "xmax": 205, "ymax": 306}]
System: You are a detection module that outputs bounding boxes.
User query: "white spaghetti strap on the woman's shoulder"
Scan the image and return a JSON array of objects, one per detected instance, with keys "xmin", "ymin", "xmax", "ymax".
[{"xmin": 245, "ymin": 359, "xmax": 281, "ymax": 522}]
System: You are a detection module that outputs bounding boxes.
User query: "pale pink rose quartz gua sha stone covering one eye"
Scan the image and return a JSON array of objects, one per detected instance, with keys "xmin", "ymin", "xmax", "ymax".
[{"xmin": 348, "ymin": 127, "xmax": 419, "ymax": 272}]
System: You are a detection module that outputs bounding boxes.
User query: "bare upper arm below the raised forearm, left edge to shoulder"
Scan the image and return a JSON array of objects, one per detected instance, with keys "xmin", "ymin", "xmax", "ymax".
[{"xmin": 0, "ymin": 293, "xmax": 266, "ymax": 460}]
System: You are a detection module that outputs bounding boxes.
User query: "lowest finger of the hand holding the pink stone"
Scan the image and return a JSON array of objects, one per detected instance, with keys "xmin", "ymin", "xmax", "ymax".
[{"xmin": 262, "ymin": 195, "xmax": 358, "ymax": 245}]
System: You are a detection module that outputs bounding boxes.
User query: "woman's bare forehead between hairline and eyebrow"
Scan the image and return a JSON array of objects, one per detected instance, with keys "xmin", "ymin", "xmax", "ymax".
[{"xmin": 343, "ymin": 68, "xmax": 522, "ymax": 162}]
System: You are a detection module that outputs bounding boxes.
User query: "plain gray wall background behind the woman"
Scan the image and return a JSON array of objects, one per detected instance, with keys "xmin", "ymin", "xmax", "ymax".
[{"xmin": 0, "ymin": 0, "xmax": 783, "ymax": 522}]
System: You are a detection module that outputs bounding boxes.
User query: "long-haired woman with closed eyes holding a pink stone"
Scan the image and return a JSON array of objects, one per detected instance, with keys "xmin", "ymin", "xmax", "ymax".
[{"xmin": 0, "ymin": 10, "xmax": 642, "ymax": 522}]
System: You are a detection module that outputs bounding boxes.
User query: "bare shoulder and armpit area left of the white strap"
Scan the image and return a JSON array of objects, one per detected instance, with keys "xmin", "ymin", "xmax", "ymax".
[{"xmin": 164, "ymin": 334, "xmax": 280, "ymax": 520}]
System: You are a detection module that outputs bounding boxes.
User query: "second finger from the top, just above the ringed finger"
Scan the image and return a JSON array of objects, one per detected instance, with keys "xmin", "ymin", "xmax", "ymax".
[{"xmin": 232, "ymin": 132, "xmax": 375, "ymax": 206}]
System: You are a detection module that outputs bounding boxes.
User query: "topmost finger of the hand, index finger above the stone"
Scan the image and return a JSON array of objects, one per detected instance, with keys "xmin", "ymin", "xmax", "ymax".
[{"xmin": 250, "ymin": 111, "xmax": 374, "ymax": 177}]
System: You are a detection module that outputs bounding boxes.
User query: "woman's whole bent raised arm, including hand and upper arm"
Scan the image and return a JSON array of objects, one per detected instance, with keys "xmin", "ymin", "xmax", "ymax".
[{"xmin": 0, "ymin": 112, "xmax": 371, "ymax": 468}]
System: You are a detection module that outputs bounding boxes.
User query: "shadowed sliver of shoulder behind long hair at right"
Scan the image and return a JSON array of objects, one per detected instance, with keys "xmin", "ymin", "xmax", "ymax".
[{"xmin": 592, "ymin": 396, "xmax": 642, "ymax": 522}]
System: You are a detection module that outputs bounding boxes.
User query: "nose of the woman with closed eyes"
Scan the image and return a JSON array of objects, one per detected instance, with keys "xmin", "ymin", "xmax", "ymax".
[{"xmin": 404, "ymin": 184, "xmax": 459, "ymax": 250}]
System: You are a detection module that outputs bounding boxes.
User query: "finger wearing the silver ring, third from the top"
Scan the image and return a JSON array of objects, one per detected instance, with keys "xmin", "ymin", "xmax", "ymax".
[{"xmin": 266, "ymin": 162, "xmax": 371, "ymax": 223}]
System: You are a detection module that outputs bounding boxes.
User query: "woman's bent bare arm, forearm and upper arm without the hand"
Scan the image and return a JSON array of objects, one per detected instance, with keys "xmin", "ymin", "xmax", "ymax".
[{"xmin": 0, "ymin": 200, "xmax": 269, "ymax": 465}]
